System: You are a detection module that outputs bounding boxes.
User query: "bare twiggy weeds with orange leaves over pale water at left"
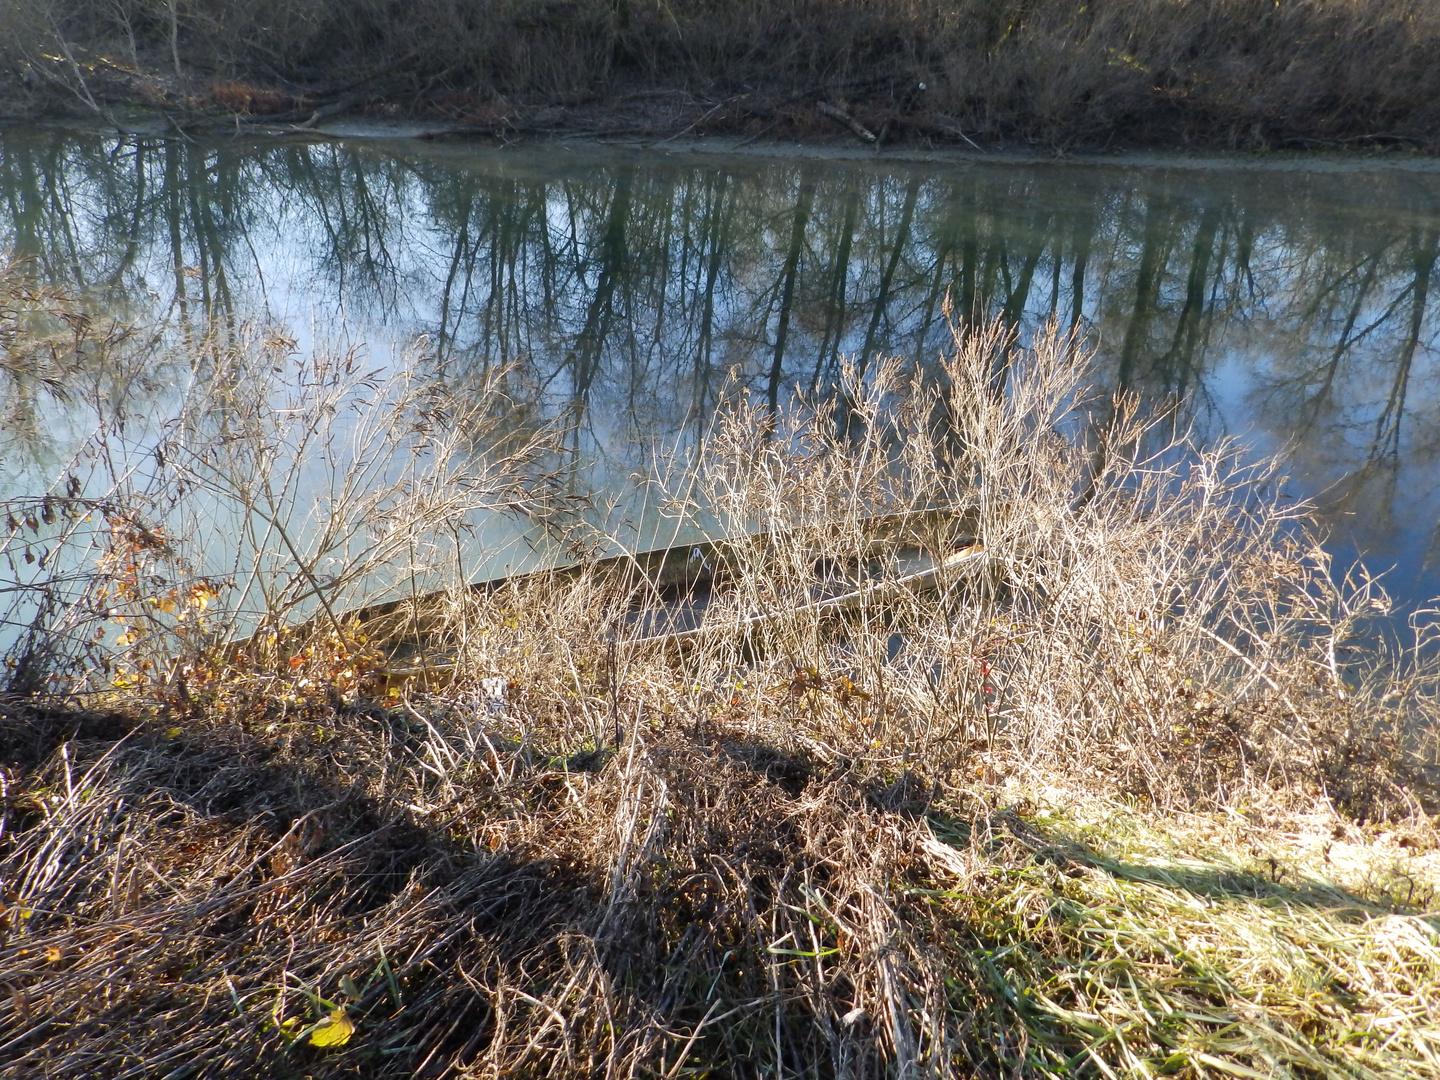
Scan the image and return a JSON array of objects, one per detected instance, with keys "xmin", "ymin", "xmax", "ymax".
[{"xmin": 0, "ymin": 312, "xmax": 576, "ymax": 694}]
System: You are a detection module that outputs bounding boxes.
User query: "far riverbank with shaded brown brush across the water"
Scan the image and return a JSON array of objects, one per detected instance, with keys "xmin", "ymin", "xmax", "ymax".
[{"xmin": 0, "ymin": 0, "xmax": 1440, "ymax": 153}]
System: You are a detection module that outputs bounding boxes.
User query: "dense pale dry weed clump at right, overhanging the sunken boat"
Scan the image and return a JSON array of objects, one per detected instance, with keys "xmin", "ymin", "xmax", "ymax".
[{"xmin": 610, "ymin": 316, "xmax": 1436, "ymax": 804}]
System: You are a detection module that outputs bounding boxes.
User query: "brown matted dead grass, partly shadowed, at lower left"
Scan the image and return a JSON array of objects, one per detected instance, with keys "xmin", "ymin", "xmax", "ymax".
[{"xmin": 0, "ymin": 707, "xmax": 840, "ymax": 1077}]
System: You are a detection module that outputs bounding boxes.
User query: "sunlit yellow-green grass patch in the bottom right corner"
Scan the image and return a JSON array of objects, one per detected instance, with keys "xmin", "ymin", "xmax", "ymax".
[{"xmin": 937, "ymin": 788, "xmax": 1440, "ymax": 1077}]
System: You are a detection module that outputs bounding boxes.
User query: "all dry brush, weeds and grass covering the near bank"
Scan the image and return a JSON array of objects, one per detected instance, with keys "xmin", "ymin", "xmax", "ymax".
[{"xmin": 0, "ymin": 276, "xmax": 1440, "ymax": 1079}]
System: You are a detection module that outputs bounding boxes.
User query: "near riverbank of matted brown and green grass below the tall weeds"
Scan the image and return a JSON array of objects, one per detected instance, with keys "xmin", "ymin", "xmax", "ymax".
[{"xmin": 0, "ymin": 694, "xmax": 1440, "ymax": 1080}]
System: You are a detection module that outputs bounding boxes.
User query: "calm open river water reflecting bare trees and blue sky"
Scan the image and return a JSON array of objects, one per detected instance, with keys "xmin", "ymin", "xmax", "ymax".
[{"xmin": 0, "ymin": 131, "xmax": 1440, "ymax": 624}]
